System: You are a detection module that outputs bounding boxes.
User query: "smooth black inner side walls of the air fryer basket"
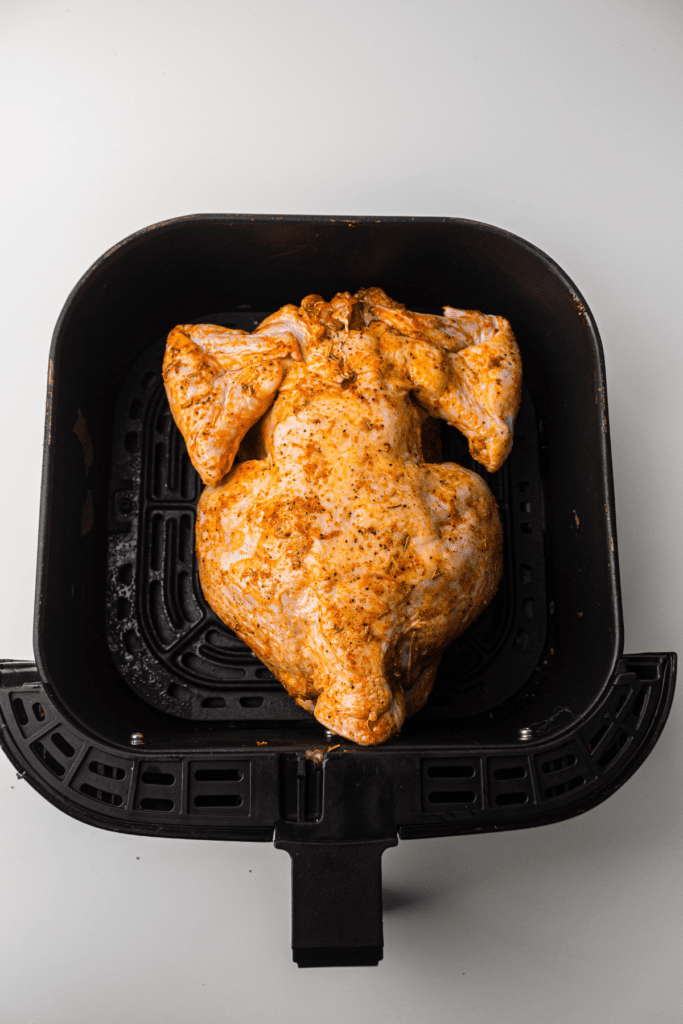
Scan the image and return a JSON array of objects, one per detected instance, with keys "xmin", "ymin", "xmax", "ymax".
[{"xmin": 36, "ymin": 216, "xmax": 622, "ymax": 743}]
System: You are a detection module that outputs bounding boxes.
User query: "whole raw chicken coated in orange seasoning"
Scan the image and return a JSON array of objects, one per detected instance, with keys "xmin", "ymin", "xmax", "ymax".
[{"xmin": 164, "ymin": 288, "xmax": 521, "ymax": 744}]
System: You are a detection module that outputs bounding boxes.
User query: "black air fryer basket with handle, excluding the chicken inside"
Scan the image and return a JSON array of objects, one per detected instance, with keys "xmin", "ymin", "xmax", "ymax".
[{"xmin": 0, "ymin": 215, "xmax": 676, "ymax": 967}]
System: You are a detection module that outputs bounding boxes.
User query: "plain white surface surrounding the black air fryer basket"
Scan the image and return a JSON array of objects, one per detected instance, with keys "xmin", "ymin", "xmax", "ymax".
[{"xmin": 0, "ymin": 0, "xmax": 683, "ymax": 1024}]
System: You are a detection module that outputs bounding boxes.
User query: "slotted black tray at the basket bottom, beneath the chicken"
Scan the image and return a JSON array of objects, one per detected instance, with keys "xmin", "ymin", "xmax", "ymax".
[{"xmin": 106, "ymin": 312, "xmax": 547, "ymax": 723}]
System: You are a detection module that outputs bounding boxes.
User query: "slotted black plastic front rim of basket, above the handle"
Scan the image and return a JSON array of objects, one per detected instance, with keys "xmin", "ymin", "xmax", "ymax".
[{"xmin": 0, "ymin": 654, "xmax": 676, "ymax": 842}]
